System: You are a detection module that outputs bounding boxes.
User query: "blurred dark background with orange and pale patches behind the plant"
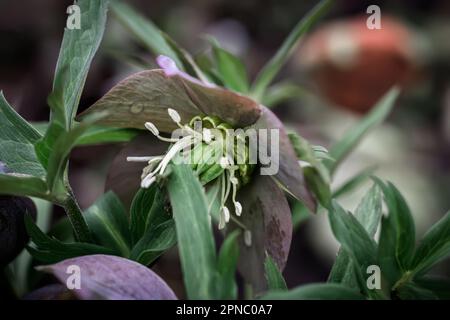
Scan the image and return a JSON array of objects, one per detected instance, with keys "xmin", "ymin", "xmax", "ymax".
[{"xmin": 0, "ymin": 0, "xmax": 450, "ymax": 296}]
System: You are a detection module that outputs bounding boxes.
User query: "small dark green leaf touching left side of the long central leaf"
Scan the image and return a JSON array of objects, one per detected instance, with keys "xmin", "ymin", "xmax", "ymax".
[{"xmin": 130, "ymin": 219, "xmax": 177, "ymax": 265}]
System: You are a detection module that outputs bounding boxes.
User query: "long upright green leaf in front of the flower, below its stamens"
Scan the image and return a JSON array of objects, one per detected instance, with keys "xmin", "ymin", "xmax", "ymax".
[{"xmin": 167, "ymin": 164, "xmax": 216, "ymax": 299}]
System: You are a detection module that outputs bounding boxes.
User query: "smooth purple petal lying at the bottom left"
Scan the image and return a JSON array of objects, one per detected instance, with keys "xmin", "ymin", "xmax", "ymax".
[{"xmin": 38, "ymin": 254, "xmax": 177, "ymax": 300}]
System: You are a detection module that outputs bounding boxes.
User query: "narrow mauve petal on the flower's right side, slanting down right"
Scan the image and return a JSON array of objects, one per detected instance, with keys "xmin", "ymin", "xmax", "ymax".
[{"xmin": 250, "ymin": 107, "xmax": 317, "ymax": 212}]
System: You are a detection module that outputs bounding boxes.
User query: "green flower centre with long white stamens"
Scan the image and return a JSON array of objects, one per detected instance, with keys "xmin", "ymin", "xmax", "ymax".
[{"xmin": 127, "ymin": 108, "xmax": 255, "ymax": 229}]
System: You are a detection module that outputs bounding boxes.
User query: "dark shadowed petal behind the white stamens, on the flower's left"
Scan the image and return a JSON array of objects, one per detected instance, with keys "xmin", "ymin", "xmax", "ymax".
[{"xmin": 105, "ymin": 133, "xmax": 168, "ymax": 208}]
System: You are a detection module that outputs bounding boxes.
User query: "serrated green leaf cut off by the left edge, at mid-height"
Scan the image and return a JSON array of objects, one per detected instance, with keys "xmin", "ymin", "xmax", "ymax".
[{"xmin": 0, "ymin": 91, "xmax": 45, "ymax": 178}]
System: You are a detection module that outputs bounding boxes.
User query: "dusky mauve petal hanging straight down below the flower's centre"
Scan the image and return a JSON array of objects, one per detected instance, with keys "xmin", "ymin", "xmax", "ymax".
[{"xmin": 232, "ymin": 176, "xmax": 292, "ymax": 293}]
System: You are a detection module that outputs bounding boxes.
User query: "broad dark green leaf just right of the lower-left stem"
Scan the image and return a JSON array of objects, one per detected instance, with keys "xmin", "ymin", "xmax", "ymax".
[{"xmin": 84, "ymin": 191, "xmax": 131, "ymax": 257}]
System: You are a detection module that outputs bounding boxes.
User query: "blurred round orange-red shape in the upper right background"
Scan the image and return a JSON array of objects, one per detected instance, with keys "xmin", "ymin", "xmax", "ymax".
[{"xmin": 297, "ymin": 16, "xmax": 421, "ymax": 113}]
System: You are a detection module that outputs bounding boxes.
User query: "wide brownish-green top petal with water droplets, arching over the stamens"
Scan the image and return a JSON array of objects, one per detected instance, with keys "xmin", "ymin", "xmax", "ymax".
[{"xmin": 79, "ymin": 70, "xmax": 261, "ymax": 132}]
